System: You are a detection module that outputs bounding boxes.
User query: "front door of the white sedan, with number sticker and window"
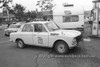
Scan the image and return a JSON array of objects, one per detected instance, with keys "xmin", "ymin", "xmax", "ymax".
[{"xmin": 34, "ymin": 23, "xmax": 49, "ymax": 46}]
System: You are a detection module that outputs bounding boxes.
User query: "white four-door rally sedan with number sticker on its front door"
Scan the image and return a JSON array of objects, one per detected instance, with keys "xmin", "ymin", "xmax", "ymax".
[{"xmin": 10, "ymin": 21, "xmax": 81, "ymax": 54}]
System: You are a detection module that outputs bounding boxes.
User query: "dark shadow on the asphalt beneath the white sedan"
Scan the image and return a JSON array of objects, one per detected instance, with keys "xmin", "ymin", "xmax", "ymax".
[{"xmin": 15, "ymin": 45, "xmax": 87, "ymax": 55}]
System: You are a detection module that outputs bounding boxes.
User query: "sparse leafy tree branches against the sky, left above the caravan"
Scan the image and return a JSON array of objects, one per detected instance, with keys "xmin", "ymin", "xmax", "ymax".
[{"xmin": 36, "ymin": 0, "xmax": 55, "ymax": 10}]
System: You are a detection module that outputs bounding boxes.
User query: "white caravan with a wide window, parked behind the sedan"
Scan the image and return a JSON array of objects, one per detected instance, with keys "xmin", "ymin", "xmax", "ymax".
[{"xmin": 53, "ymin": 5, "xmax": 84, "ymax": 31}]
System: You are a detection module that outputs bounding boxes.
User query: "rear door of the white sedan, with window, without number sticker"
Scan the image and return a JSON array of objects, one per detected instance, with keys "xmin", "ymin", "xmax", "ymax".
[{"xmin": 21, "ymin": 24, "xmax": 34, "ymax": 45}]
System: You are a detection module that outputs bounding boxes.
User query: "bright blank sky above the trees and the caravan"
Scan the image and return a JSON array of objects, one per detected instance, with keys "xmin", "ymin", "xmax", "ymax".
[{"xmin": 0, "ymin": 0, "xmax": 93, "ymax": 11}]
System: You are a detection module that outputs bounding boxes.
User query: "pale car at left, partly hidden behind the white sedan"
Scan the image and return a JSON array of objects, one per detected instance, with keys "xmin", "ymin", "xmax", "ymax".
[{"xmin": 4, "ymin": 24, "xmax": 21, "ymax": 36}]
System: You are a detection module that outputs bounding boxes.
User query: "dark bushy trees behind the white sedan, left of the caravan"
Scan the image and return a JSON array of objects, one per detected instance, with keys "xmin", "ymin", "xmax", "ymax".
[{"xmin": 9, "ymin": 4, "xmax": 37, "ymax": 21}]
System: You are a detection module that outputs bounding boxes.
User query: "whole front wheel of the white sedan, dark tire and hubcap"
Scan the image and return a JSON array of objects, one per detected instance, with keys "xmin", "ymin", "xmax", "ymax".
[{"xmin": 54, "ymin": 41, "xmax": 69, "ymax": 54}]
